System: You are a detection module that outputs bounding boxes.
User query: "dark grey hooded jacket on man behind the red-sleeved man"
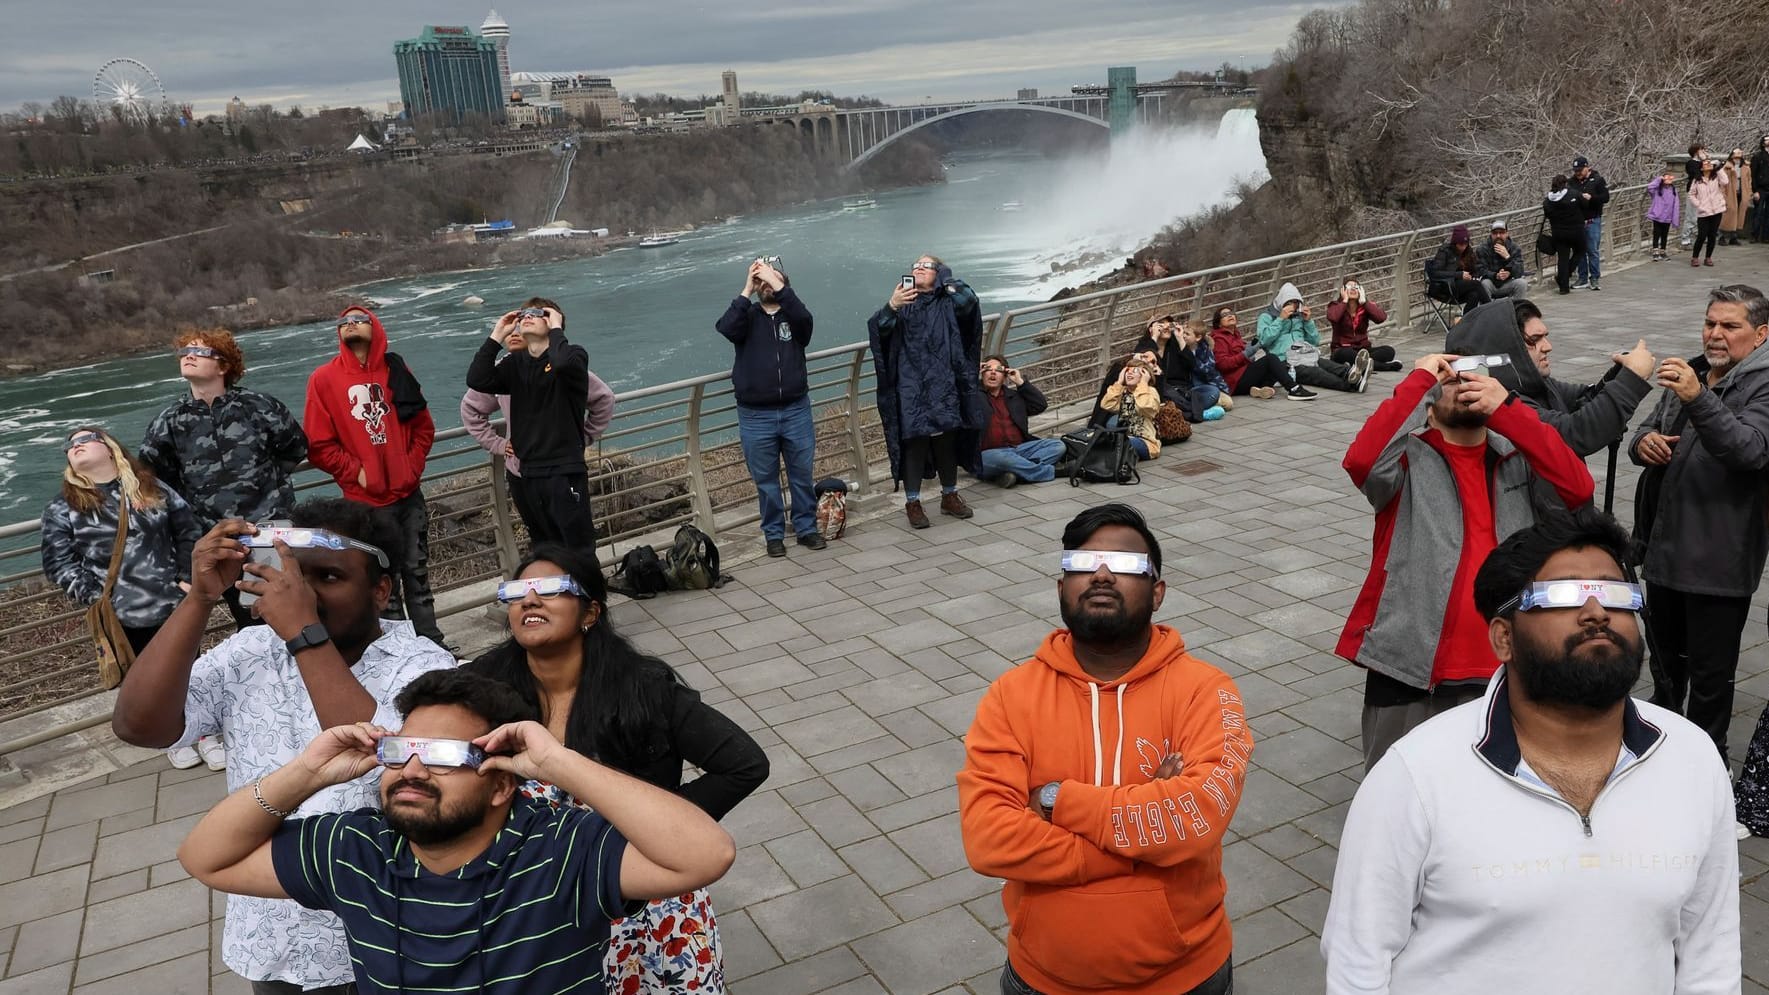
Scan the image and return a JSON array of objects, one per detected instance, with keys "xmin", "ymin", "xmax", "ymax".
[{"xmin": 1444, "ymin": 301, "xmax": 1652, "ymax": 459}]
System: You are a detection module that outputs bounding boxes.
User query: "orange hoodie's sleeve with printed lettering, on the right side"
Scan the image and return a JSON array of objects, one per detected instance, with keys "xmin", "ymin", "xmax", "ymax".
[{"xmin": 1051, "ymin": 664, "xmax": 1252, "ymax": 868}]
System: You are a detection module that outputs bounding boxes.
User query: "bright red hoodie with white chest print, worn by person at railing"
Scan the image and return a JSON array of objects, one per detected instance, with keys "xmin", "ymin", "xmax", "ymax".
[{"xmin": 302, "ymin": 308, "xmax": 437, "ymax": 508}]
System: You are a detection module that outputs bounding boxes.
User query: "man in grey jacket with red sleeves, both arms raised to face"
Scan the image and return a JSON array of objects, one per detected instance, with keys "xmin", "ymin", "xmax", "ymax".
[{"xmin": 1337, "ymin": 354, "xmax": 1594, "ymax": 770}]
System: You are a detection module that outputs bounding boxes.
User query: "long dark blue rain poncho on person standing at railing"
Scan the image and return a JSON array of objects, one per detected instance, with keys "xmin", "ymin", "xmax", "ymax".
[{"xmin": 867, "ymin": 264, "xmax": 989, "ymax": 489}]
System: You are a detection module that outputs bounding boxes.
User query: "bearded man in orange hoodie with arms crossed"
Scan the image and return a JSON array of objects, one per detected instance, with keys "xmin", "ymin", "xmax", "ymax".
[{"xmin": 959, "ymin": 505, "xmax": 1252, "ymax": 995}]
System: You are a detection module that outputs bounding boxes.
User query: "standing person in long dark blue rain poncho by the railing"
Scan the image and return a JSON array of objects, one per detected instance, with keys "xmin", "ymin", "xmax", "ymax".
[{"xmin": 867, "ymin": 255, "xmax": 989, "ymax": 529}]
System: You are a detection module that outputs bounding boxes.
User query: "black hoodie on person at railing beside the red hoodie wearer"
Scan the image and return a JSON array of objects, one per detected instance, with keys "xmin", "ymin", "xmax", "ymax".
[{"xmin": 467, "ymin": 329, "xmax": 589, "ymax": 478}]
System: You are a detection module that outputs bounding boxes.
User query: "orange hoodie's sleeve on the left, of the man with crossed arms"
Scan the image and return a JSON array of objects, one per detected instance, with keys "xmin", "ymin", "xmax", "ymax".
[{"xmin": 959, "ymin": 683, "xmax": 1134, "ymax": 885}]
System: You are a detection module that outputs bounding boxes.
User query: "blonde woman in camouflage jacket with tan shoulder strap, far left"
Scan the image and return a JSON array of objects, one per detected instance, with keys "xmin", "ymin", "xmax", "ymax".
[{"xmin": 42, "ymin": 425, "xmax": 214, "ymax": 770}]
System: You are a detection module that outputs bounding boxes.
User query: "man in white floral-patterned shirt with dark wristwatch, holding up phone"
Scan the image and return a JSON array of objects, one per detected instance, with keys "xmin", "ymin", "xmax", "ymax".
[{"xmin": 111, "ymin": 499, "xmax": 455, "ymax": 995}]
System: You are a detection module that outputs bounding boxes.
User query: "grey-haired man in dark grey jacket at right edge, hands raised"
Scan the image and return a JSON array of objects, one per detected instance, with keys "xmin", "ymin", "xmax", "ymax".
[{"xmin": 1627, "ymin": 283, "xmax": 1769, "ymax": 760}]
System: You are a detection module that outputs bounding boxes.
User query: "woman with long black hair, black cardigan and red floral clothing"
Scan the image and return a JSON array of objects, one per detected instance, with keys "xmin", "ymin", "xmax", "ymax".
[{"xmin": 467, "ymin": 544, "xmax": 768, "ymax": 995}]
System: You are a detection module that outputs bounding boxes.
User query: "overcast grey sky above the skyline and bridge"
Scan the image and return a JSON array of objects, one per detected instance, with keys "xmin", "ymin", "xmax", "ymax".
[{"xmin": 0, "ymin": 0, "xmax": 1332, "ymax": 113}]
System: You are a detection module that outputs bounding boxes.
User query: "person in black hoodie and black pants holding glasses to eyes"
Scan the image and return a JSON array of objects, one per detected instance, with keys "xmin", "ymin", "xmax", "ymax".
[{"xmin": 467, "ymin": 297, "xmax": 596, "ymax": 554}]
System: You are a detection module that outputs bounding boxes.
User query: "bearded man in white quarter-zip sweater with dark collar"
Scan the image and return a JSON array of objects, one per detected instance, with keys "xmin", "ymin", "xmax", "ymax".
[{"xmin": 1321, "ymin": 506, "xmax": 1742, "ymax": 995}]
